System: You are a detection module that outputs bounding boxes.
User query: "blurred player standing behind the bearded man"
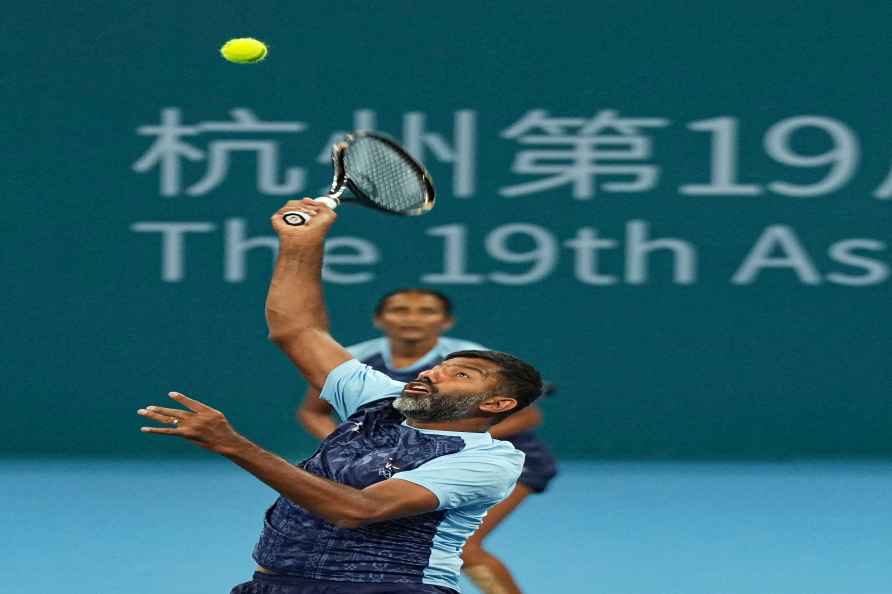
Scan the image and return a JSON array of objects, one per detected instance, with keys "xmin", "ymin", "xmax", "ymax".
[{"xmin": 297, "ymin": 288, "xmax": 556, "ymax": 594}]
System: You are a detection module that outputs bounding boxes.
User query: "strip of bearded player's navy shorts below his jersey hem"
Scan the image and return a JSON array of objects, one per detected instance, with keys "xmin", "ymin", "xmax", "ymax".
[{"xmin": 229, "ymin": 572, "xmax": 458, "ymax": 594}]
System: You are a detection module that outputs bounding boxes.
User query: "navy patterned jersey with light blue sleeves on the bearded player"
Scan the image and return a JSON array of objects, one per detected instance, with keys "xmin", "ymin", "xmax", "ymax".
[{"xmin": 254, "ymin": 359, "xmax": 524, "ymax": 590}]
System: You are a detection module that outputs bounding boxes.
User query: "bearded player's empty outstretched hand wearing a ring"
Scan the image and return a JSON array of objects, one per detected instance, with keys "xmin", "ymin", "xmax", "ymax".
[{"xmin": 136, "ymin": 392, "xmax": 245, "ymax": 455}]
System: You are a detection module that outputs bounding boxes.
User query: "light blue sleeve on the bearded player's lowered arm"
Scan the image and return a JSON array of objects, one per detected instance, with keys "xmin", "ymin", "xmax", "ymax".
[{"xmin": 390, "ymin": 445, "xmax": 524, "ymax": 510}]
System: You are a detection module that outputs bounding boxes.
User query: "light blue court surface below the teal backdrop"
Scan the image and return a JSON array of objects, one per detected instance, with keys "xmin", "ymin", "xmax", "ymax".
[{"xmin": 0, "ymin": 455, "xmax": 892, "ymax": 594}]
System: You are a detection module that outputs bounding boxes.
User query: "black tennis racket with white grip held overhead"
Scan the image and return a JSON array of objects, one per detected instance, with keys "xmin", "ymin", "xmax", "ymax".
[{"xmin": 282, "ymin": 132, "xmax": 434, "ymax": 226}]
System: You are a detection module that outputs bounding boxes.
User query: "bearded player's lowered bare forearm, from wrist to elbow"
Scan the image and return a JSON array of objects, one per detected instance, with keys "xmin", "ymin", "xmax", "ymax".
[{"xmin": 220, "ymin": 437, "xmax": 373, "ymax": 528}]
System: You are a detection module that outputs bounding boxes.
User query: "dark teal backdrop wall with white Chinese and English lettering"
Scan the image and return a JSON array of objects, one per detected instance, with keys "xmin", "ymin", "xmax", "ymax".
[{"xmin": 0, "ymin": 0, "xmax": 892, "ymax": 459}]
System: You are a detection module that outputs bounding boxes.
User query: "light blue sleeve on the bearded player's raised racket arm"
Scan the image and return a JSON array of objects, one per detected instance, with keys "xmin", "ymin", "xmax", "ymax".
[{"xmin": 319, "ymin": 359, "xmax": 405, "ymax": 420}]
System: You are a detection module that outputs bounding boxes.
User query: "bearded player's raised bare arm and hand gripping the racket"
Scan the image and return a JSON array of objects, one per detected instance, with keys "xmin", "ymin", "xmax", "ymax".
[{"xmin": 266, "ymin": 198, "xmax": 352, "ymax": 390}]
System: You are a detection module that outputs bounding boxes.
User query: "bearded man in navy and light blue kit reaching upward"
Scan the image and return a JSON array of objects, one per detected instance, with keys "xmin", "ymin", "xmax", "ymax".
[{"xmin": 139, "ymin": 199, "xmax": 542, "ymax": 594}]
